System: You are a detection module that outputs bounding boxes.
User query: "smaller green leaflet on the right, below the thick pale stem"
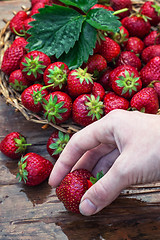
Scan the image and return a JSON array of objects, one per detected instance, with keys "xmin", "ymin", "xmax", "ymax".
[{"xmin": 86, "ymin": 8, "xmax": 121, "ymax": 32}]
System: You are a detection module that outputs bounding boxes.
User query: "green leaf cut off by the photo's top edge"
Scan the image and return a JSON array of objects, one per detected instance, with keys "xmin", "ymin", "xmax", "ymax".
[{"xmin": 60, "ymin": 0, "xmax": 98, "ymax": 12}]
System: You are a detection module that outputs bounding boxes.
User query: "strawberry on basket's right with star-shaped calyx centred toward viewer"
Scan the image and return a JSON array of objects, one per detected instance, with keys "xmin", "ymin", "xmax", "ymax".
[{"xmin": 112, "ymin": 67, "xmax": 142, "ymax": 99}]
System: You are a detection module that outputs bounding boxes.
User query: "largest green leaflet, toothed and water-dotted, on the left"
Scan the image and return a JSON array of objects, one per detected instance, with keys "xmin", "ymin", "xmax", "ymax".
[{"xmin": 27, "ymin": 5, "xmax": 84, "ymax": 58}]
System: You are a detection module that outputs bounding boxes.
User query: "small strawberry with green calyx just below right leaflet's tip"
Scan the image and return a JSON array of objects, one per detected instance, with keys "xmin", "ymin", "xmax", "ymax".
[{"xmin": 111, "ymin": 26, "xmax": 129, "ymax": 47}]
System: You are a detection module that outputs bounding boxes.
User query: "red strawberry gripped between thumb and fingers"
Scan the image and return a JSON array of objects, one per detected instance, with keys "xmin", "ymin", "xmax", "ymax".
[{"xmin": 56, "ymin": 169, "xmax": 93, "ymax": 213}]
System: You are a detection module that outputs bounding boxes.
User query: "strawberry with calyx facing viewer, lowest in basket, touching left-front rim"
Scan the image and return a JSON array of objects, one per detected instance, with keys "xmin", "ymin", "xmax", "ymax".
[{"xmin": 43, "ymin": 91, "xmax": 72, "ymax": 124}]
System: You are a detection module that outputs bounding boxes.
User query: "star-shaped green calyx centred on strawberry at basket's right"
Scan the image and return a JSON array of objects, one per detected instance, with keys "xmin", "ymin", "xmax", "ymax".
[{"xmin": 116, "ymin": 70, "xmax": 139, "ymax": 96}]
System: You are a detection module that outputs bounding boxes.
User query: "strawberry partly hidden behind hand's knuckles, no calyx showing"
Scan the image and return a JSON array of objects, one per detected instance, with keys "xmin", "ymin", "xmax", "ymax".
[{"xmin": 103, "ymin": 92, "xmax": 129, "ymax": 115}]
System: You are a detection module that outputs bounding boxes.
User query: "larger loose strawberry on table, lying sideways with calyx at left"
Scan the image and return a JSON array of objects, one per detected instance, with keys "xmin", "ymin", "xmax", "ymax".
[{"xmin": 17, "ymin": 152, "xmax": 53, "ymax": 186}]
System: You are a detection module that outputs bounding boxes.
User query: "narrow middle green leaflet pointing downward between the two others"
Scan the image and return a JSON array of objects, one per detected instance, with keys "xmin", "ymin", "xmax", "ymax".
[{"xmin": 60, "ymin": 22, "xmax": 97, "ymax": 69}]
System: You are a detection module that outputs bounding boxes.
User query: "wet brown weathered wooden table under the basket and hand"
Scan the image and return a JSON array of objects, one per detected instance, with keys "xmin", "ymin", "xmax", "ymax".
[{"xmin": 0, "ymin": 1, "xmax": 160, "ymax": 240}]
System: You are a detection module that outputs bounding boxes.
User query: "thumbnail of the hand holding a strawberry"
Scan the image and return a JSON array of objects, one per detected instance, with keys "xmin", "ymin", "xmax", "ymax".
[{"xmin": 79, "ymin": 198, "xmax": 97, "ymax": 216}]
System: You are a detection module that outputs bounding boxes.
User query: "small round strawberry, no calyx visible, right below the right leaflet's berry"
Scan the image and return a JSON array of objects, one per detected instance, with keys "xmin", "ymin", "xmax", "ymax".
[{"xmin": 126, "ymin": 37, "xmax": 144, "ymax": 54}]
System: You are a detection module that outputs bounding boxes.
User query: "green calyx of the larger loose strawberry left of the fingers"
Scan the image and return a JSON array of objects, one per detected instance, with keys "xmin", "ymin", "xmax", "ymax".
[{"xmin": 16, "ymin": 156, "xmax": 28, "ymax": 183}]
